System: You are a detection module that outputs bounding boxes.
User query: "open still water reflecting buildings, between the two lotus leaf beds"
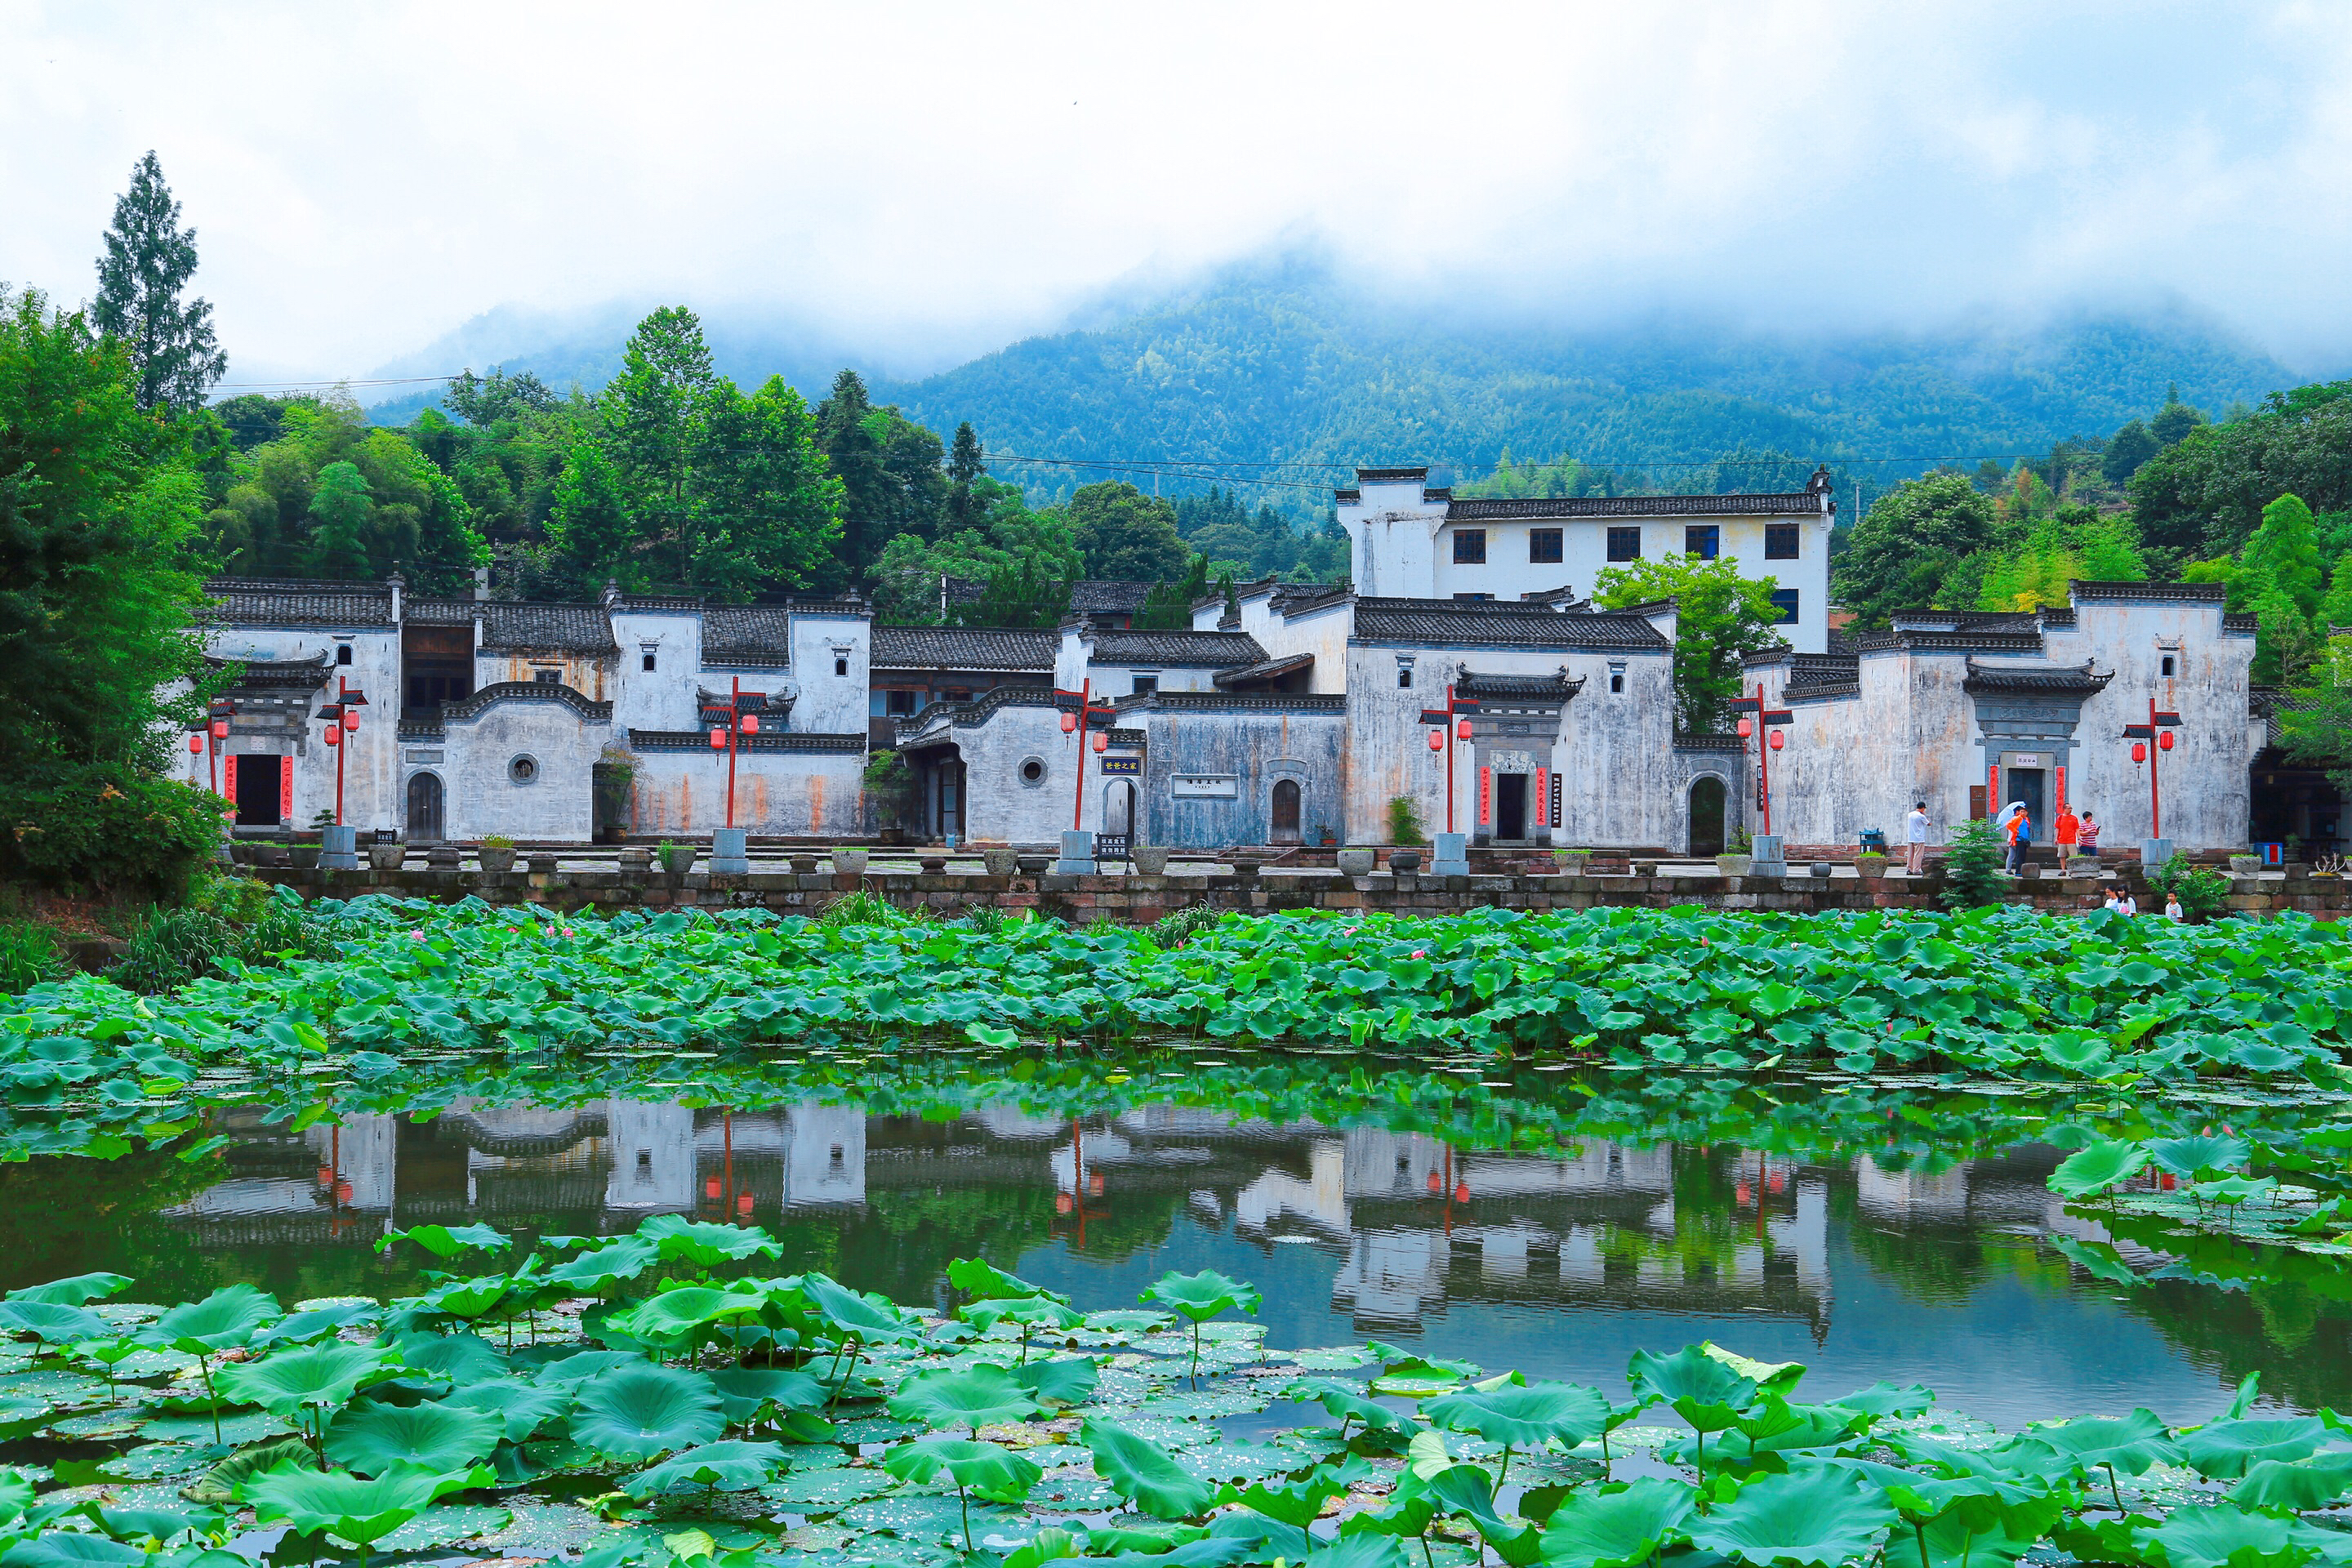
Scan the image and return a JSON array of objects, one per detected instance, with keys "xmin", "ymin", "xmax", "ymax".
[{"xmin": 0, "ymin": 1081, "xmax": 2352, "ymax": 1429}]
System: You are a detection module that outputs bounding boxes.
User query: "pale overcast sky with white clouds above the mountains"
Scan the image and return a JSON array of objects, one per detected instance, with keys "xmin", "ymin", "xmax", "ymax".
[{"xmin": 13, "ymin": 0, "xmax": 2352, "ymax": 381}]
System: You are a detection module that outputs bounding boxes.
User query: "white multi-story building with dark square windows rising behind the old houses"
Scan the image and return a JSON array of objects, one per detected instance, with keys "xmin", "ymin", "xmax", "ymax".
[{"xmin": 1334, "ymin": 468, "xmax": 1837, "ymax": 653}]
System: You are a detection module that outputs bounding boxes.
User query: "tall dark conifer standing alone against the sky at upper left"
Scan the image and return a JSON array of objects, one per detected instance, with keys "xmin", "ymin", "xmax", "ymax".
[{"xmin": 89, "ymin": 150, "xmax": 228, "ymax": 412}]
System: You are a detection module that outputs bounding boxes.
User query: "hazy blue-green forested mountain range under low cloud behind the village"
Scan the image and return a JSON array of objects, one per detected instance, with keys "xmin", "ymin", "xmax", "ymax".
[{"xmin": 376, "ymin": 263, "xmax": 2301, "ymax": 510}]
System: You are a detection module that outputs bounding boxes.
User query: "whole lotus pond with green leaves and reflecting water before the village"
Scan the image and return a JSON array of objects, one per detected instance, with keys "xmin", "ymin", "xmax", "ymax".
[{"xmin": 0, "ymin": 900, "xmax": 2352, "ymax": 1568}]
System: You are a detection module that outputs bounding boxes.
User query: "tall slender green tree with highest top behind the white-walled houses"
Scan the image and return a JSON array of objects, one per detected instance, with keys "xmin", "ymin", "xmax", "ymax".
[{"xmin": 607, "ymin": 305, "xmax": 719, "ymax": 583}]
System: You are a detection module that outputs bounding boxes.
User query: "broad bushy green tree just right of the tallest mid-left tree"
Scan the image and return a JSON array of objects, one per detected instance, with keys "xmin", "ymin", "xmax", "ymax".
[{"xmin": 689, "ymin": 376, "xmax": 842, "ymax": 602}]
